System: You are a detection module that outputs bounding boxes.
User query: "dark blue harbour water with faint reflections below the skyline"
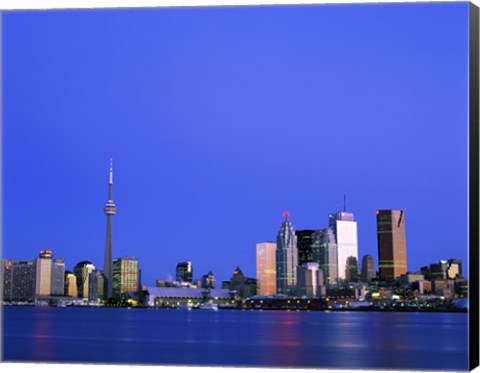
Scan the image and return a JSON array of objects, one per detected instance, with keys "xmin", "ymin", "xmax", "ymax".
[{"xmin": 3, "ymin": 307, "xmax": 468, "ymax": 370}]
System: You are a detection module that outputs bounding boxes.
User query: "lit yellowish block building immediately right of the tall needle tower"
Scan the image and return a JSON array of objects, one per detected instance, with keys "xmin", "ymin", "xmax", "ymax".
[{"xmin": 113, "ymin": 256, "xmax": 139, "ymax": 297}]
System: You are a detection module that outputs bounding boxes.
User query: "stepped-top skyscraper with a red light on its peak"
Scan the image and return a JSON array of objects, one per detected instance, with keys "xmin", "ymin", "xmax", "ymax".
[{"xmin": 275, "ymin": 212, "xmax": 298, "ymax": 296}]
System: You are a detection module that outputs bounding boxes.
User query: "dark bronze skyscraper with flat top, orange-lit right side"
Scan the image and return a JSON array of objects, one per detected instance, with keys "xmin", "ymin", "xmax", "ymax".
[{"xmin": 377, "ymin": 210, "xmax": 407, "ymax": 283}]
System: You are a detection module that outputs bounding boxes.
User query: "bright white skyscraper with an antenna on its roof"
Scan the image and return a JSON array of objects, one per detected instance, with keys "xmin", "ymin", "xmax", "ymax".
[{"xmin": 329, "ymin": 210, "xmax": 358, "ymax": 283}]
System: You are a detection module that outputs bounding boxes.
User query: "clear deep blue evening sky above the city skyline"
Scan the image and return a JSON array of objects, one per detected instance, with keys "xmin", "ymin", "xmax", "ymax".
[{"xmin": 2, "ymin": 3, "xmax": 468, "ymax": 285}]
